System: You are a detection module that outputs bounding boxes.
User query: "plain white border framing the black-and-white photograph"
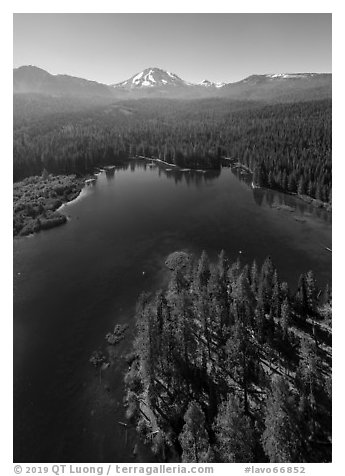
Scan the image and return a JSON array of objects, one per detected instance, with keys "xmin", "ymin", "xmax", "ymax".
[{"xmin": 0, "ymin": 4, "xmax": 345, "ymax": 476}]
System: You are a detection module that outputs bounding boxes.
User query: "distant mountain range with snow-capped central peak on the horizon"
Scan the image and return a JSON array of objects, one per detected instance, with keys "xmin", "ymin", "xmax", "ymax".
[{"xmin": 13, "ymin": 66, "xmax": 332, "ymax": 102}]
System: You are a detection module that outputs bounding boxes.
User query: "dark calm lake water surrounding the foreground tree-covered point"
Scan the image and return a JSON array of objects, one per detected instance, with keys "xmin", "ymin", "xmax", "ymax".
[{"xmin": 14, "ymin": 162, "xmax": 332, "ymax": 462}]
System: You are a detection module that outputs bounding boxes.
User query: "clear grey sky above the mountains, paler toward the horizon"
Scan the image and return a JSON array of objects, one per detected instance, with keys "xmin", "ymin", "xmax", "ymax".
[{"xmin": 14, "ymin": 13, "xmax": 332, "ymax": 84}]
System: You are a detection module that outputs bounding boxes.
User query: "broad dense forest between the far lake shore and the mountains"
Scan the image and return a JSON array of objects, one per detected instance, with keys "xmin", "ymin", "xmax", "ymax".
[{"xmin": 14, "ymin": 95, "xmax": 332, "ymax": 202}]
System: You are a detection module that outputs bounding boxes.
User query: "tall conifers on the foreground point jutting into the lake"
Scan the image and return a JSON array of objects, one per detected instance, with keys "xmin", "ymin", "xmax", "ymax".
[{"xmin": 125, "ymin": 252, "xmax": 331, "ymax": 463}]
